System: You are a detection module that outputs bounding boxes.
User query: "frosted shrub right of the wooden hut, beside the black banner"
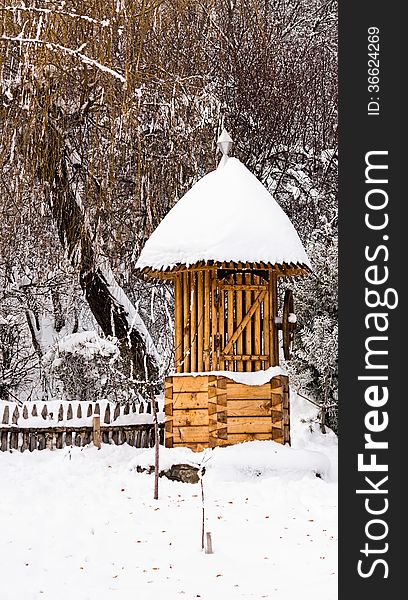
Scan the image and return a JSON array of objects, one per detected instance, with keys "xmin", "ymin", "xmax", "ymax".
[{"xmin": 286, "ymin": 230, "xmax": 338, "ymax": 431}]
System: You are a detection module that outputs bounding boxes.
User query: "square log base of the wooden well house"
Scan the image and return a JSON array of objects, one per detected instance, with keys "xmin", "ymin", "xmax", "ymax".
[{"xmin": 164, "ymin": 375, "xmax": 290, "ymax": 452}]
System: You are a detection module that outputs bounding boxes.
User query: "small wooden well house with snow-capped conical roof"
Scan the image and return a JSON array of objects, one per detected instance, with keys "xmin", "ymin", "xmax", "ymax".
[{"xmin": 136, "ymin": 130, "xmax": 310, "ymax": 450}]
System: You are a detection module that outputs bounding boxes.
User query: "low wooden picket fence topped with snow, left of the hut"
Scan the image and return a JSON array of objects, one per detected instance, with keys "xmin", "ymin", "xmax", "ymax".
[{"xmin": 0, "ymin": 401, "xmax": 164, "ymax": 452}]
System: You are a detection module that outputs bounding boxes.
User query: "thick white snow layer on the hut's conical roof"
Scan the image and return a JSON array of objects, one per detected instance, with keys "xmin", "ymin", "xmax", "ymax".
[{"xmin": 136, "ymin": 157, "xmax": 310, "ymax": 270}]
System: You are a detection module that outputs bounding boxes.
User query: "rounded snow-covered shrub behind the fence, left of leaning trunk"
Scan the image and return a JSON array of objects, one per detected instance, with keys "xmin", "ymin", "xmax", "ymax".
[{"xmin": 43, "ymin": 331, "xmax": 135, "ymax": 401}]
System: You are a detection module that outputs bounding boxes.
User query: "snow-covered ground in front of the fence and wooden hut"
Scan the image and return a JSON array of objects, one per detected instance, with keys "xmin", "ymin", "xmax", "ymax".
[{"xmin": 0, "ymin": 399, "xmax": 337, "ymax": 600}]
